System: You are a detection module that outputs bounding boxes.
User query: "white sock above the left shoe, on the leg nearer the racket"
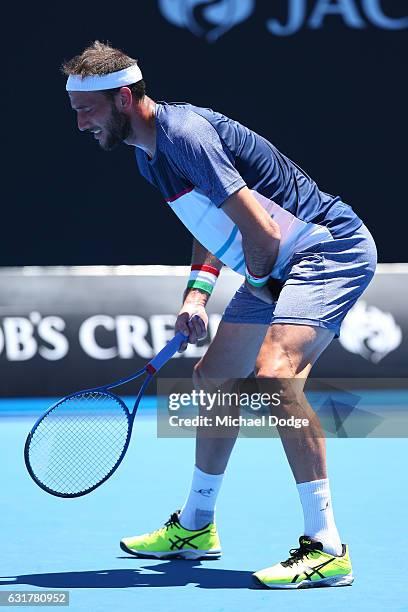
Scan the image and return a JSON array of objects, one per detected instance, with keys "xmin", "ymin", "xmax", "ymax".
[{"xmin": 179, "ymin": 466, "xmax": 224, "ymax": 529}]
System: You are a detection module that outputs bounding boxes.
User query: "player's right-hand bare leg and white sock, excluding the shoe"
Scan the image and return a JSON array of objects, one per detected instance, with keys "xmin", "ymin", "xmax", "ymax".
[{"xmin": 256, "ymin": 324, "xmax": 342, "ymax": 554}]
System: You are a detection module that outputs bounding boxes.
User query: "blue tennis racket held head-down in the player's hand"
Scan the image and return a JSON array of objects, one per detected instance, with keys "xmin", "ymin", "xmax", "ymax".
[{"xmin": 24, "ymin": 332, "xmax": 187, "ymax": 497}]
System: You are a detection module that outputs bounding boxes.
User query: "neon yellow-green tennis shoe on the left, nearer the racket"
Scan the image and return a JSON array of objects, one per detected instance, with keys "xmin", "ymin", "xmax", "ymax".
[{"xmin": 120, "ymin": 512, "xmax": 221, "ymax": 559}]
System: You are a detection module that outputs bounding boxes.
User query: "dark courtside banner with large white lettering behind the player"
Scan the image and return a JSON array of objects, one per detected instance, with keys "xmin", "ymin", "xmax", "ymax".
[{"xmin": 0, "ymin": 266, "xmax": 408, "ymax": 397}]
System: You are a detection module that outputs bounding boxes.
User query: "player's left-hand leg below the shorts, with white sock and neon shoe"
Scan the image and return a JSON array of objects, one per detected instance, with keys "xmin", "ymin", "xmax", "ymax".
[{"xmin": 120, "ymin": 318, "xmax": 271, "ymax": 559}]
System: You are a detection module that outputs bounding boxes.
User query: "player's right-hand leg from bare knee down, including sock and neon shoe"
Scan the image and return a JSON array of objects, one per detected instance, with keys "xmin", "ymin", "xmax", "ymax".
[{"xmin": 254, "ymin": 324, "xmax": 353, "ymax": 588}]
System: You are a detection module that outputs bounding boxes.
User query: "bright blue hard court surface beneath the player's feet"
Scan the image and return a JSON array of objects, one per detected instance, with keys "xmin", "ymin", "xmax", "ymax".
[{"xmin": 0, "ymin": 397, "xmax": 408, "ymax": 612}]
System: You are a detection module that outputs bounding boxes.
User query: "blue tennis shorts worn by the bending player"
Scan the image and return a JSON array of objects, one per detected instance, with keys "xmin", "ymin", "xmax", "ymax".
[{"xmin": 222, "ymin": 225, "xmax": 377, "ymax": 337}]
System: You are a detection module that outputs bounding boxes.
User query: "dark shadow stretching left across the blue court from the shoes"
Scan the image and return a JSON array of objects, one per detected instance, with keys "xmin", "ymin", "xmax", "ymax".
[{"xmin": 0, "ymin": 559, "xmax": 256, "ymax": 589}]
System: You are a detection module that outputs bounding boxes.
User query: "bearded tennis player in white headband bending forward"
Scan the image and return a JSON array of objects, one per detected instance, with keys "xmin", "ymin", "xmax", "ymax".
[{"xmin": 63, "ymin": 41, "xmax": 376, "ymax": 588}]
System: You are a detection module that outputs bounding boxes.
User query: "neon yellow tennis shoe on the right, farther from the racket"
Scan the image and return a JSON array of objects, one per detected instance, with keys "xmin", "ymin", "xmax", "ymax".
[{"xmin": 253, "ymin": 536, "xmax": 354, "ymax": 589}]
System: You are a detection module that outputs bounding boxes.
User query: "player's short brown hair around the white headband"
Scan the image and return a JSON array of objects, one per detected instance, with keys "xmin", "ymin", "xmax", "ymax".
[{"xmin": 61, "ymin": 40, "xmax": 146, "ymax": 100}]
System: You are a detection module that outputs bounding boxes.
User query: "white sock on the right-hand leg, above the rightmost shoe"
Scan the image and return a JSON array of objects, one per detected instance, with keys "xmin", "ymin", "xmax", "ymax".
[{"xmin": 297, "ymin": 478, "xmax": 342, "ymax": 556}]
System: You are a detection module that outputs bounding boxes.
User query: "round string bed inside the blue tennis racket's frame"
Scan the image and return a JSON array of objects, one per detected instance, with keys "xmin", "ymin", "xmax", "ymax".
[{"xmin": 29, "ymin": 392, "xmax": 130, "ymax": 495}]
